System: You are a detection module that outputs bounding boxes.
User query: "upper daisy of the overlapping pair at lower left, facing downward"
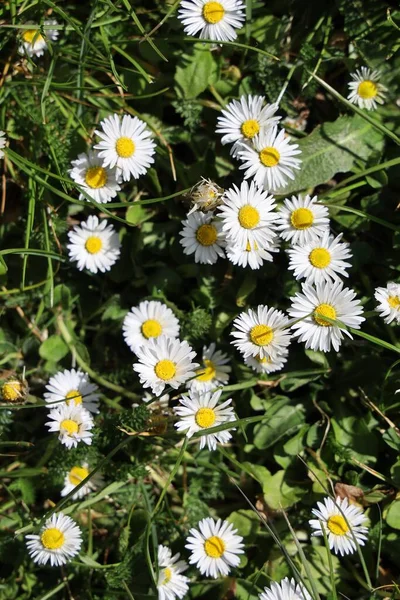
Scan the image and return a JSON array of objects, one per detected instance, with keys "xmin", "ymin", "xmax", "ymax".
[{"xmin": 44, "ymin": 369, "xmax": 99, "ymax": 413}]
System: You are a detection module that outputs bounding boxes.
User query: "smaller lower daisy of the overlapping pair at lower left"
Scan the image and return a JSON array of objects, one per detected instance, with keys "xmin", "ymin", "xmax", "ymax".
[{"xmin": 45, "ymin": 404, "xmax": 94, "ymax": 449}]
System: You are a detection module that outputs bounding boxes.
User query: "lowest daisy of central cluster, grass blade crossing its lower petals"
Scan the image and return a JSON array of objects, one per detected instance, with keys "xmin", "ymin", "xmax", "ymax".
[{"xmin": 174, "ymin": 390, "xmax": 236, "ymax": 450}]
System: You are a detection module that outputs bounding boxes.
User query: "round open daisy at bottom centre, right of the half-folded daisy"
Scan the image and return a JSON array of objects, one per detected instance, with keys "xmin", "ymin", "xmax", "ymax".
[{"xmin": 185, "ymin": 517, "xmax": 244, "ymax": 579}]
